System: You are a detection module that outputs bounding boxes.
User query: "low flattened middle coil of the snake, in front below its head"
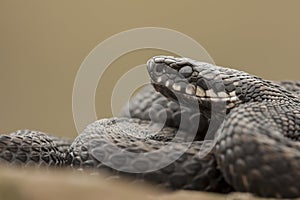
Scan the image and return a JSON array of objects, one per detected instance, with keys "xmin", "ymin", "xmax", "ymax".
[{"xmin": 66, "ymin": 118, "xmax": 232, "ymax": 193}]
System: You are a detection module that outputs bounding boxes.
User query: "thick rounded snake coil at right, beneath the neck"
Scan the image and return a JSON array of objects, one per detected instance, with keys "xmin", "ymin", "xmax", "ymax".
[{"xmin": 216, "ymin": 102, "xmax": 300, "ymax": 197}]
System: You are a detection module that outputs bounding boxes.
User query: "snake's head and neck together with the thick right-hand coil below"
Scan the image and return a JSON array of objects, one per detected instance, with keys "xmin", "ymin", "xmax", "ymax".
[{"xmin": 148, "ymin": 56, "xmax": 300, "ymax": 197}]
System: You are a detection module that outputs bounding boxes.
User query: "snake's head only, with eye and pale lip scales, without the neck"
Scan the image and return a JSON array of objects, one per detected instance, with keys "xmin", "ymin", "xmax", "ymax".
[{"xmin": 147, "ymin": 56, "xmax": 238, "ymax": 108}]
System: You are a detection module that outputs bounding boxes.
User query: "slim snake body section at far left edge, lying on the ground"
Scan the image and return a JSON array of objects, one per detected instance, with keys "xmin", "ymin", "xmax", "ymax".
[{"xmin": 0, "ymin": 130, "xmax": 70, "ymax": 167}]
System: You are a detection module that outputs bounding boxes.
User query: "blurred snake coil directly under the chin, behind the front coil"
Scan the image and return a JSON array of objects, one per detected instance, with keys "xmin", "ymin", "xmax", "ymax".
[{"xmin": 121, "ymin": 85, "xmax": 209, "ymax": 140}]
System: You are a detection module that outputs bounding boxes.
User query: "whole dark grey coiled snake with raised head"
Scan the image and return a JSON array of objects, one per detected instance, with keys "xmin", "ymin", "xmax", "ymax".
[{"xmin": 0, "ymin": 56, "xmax": 300, "ymax": 198}]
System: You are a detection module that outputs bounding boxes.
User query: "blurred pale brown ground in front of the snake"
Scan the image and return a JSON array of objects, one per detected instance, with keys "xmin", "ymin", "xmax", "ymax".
[{"xmin": 0, "ymin": 167, "xmax": 284, "ymax": 200}]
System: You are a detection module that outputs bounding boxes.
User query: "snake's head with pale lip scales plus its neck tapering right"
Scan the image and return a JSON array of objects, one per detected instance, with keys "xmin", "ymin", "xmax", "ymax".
[{"xmin": 147, "ymin": 56, "xmax": 299, "ymax": 112}]
